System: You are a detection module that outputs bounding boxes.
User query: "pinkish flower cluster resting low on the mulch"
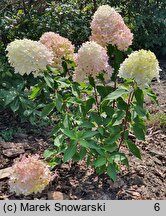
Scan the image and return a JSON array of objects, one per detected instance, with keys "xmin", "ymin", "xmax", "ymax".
[{"xmin": 9, "ymin": 155, "xmax": 52, "ymax": 195}]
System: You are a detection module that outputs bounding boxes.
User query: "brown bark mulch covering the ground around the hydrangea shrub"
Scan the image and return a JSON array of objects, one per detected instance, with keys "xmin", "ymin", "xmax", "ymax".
[{"xmin": 0, "ymin": 81, "xmax": 166, "ymax": 200}]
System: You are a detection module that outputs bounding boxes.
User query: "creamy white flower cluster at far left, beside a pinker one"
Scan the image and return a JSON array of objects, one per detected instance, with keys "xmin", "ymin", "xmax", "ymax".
[{"xmin": 6, "ymin": 39, "xmax": 53, "ymax": 77}]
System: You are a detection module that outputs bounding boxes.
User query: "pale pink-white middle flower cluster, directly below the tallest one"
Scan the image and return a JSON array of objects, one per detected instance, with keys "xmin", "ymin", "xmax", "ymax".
[{"xmin": 74, "ymin": 41, "xmax": 112, "ymax": 82}]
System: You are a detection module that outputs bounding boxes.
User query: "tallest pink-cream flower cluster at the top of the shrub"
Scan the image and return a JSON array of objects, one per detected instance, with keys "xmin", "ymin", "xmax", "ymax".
[{"xmin": 90, "ymin": 5, "xmax": 133, "ymax": 51}]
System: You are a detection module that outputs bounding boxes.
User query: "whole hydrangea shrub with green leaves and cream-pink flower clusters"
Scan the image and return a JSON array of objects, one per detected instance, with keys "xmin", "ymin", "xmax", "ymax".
[{"xmin": 7, "ymin": 5, "xmax": 160, "ymax": 195}]
